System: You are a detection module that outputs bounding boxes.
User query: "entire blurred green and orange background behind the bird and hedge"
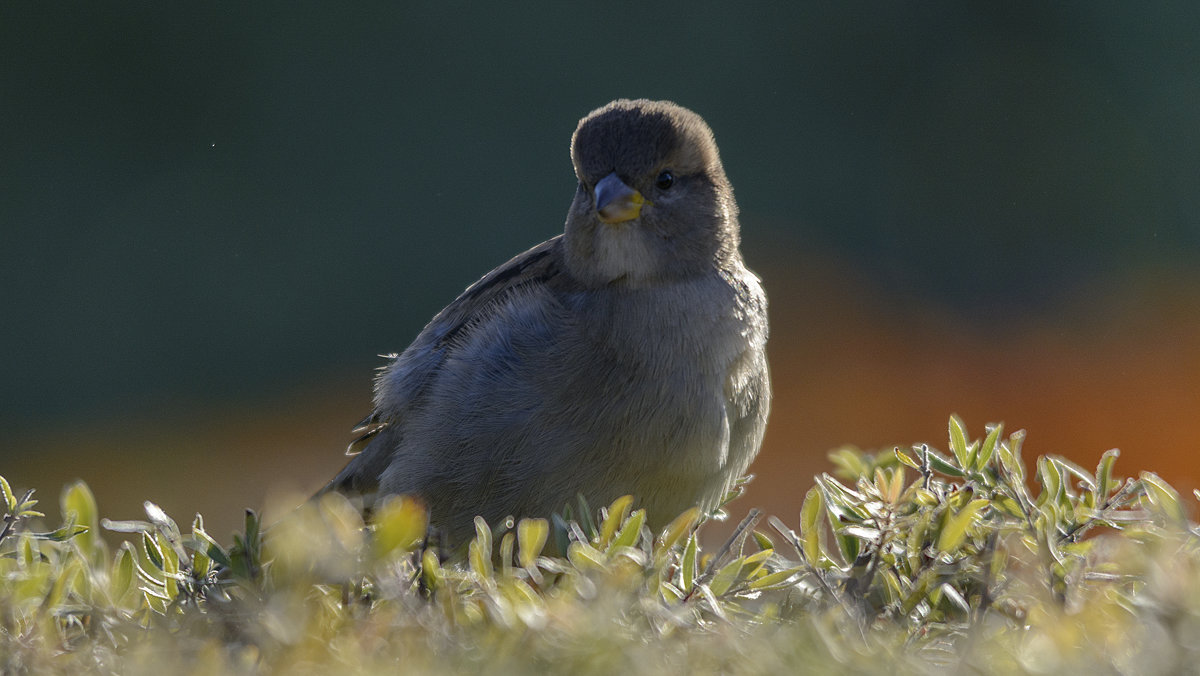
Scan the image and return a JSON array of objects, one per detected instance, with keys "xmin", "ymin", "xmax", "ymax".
[{"xmin": 0, "ymin": 0, "xmax": 1200, "ymax": 537}]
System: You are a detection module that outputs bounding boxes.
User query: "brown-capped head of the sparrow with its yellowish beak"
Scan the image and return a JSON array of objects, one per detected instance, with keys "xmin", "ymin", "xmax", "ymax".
[{"xmin": 565, "ymin": 98, "xmax": 738, "ymax": 285}]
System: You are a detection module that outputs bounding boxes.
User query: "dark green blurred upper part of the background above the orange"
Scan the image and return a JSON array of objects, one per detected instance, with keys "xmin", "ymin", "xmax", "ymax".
[{"xmin": 0, "ymin": 1, "xmax": 1200, "ymax": 444}]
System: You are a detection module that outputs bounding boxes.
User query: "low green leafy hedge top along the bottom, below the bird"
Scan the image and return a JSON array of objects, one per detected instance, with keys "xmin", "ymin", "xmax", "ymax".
[{"xmin": 0, "ymin": 418, "xmax": 1200, "ymax": 676}]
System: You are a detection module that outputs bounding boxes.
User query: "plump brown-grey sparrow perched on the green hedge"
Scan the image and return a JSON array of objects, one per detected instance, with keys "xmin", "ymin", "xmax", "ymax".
[{"xmin": 318, "ymin": 98, "xmax": 770, "ymax": 545}]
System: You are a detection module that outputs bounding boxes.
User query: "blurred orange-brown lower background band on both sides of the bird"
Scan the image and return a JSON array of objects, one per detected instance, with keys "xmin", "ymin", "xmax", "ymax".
[{"xmin": 0, "ymin": 258, "xmax": 1200, "ymax": 545}]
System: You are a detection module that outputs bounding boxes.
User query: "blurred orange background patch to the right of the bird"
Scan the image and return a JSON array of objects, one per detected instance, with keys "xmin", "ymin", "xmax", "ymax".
[{"xmin": 748, "ymin": 254, "xmax": 1200, "ymax": 522}]
